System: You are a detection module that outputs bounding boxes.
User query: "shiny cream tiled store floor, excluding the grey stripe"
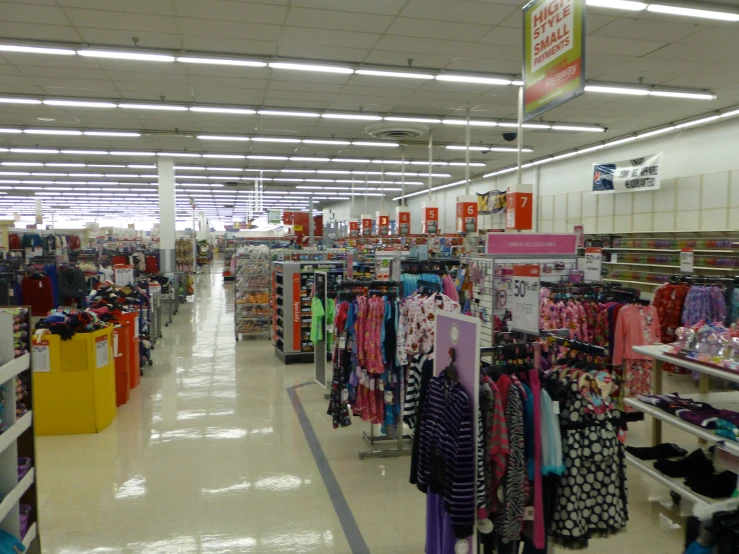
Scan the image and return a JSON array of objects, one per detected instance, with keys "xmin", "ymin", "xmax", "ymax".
[{"xmin": 38, "ymin": 260, "xmax": 695, "ymax": 554}]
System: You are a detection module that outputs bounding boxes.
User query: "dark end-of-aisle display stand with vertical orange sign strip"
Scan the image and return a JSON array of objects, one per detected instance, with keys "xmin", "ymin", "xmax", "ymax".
[{"xmin": 272, "ymin": 260, "xmax": 346, "ymax": 364}]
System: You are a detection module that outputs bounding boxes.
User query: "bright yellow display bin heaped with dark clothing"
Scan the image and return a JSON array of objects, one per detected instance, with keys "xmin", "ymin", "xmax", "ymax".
[{"xmin": 33, "ymin": 325, "xmax": 116, "ymax": 435}]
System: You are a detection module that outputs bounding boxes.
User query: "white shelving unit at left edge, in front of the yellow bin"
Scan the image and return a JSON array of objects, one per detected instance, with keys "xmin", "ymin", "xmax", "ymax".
[{"xmin": 0, "ymin": 306, "xmax": 41, "ymax": 554}]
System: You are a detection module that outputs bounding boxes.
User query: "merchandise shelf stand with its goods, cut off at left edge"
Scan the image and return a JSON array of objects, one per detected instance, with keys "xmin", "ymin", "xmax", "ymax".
[{"xmin": 0, "ymin": 306, "xmax": 41, "ymax": 554}]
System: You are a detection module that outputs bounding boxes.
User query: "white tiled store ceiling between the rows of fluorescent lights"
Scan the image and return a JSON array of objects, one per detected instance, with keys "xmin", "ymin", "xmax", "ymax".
[{"xmin": 0, "ymin": 0, "xmax": 739, "ymax": 224}]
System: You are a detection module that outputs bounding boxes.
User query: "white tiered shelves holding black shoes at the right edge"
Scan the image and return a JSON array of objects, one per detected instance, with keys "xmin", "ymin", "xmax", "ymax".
[{"xmin": 625, "ymin": 344, "xmax": 739, "ymax": 519}]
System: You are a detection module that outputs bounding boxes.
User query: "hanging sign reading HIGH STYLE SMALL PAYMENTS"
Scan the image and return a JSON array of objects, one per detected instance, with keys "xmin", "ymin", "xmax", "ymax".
[{"xmin": 523, "ymin": 0, "xmax": 587, "ymax": 121}]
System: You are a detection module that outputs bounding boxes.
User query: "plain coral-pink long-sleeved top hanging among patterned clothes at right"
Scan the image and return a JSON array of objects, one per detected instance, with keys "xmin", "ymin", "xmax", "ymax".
[{"xmin": 613, "ymin": 304, "xmax": 661, "ymax": 365}]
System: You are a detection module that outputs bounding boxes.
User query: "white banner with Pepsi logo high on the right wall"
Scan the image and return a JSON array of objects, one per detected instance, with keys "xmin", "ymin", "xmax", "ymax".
[{"xmin": 593, "ymin": 152, "xmax": 662, "ymax": 194}]
